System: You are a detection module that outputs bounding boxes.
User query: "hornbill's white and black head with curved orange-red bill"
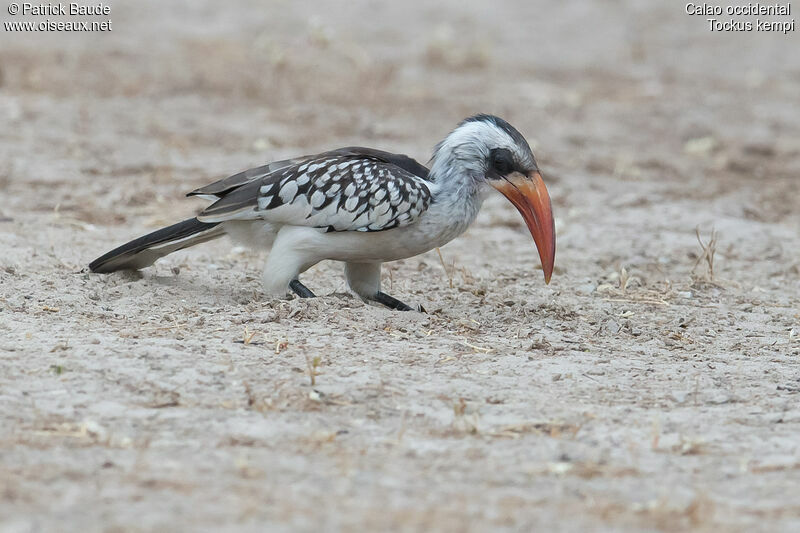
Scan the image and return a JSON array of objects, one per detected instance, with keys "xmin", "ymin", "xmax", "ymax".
[{"xmin": 431, "ymin": 115, "xmax": 556, "ymax": 283}]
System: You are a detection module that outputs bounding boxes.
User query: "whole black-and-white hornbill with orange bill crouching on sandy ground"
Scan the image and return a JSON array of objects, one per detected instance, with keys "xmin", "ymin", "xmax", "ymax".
[{"xmin": 89, "ymin": 114, "xmax": 555, "ymax": 311}]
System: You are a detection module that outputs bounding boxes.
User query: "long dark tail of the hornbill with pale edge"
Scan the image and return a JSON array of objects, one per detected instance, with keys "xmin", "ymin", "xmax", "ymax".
[{"xmin": 89, "ymin": 218, "xmax": 225, "ymax": 274}]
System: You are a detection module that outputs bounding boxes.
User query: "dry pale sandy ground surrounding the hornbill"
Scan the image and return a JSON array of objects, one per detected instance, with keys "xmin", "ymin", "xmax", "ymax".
[{"xmin": 0, "ymin": 0, "xmax": 800, "ymax": 532}]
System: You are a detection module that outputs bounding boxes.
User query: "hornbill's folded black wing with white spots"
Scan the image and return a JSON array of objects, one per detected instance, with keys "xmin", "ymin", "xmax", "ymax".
[{"xmin": 197, "ymin": 150, "xmax": 430, "ymax": 231}]
